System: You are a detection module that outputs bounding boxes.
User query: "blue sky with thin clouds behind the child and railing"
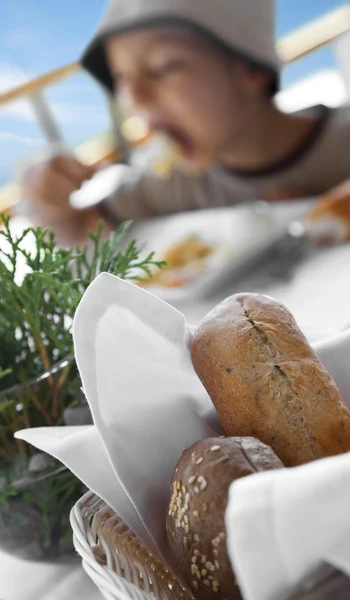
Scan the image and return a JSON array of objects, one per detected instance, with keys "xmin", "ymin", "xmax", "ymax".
[{"xmin": 0, "ymin": 0, "xmax": 347, "ymax": 186}]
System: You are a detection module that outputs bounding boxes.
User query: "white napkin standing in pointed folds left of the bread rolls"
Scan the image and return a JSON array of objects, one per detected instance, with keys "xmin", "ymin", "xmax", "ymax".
[{"xmin": 17, "ymin": 274, "xmax": 350, "ymax": 600}]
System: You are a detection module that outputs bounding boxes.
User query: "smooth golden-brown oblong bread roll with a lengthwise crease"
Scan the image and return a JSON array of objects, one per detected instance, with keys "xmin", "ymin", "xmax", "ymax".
[{"xmin": 192, "ymin": 294, "xmax": 350, "ymax": 466}]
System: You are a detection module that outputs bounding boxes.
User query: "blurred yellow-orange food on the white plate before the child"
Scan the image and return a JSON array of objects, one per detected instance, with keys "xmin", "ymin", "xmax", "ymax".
[{"xmin": 140, "ymin": 235, "xmax": 214, "ymax": 287}]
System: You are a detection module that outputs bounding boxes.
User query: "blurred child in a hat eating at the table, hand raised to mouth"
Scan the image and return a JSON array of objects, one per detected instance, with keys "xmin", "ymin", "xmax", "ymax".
[{"xmin": 24, "ymin": 0, "xmax": 350, "ymax": 242}]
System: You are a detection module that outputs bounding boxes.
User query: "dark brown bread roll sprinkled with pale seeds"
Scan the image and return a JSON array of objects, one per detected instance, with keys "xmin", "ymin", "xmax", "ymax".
[{"xmin": 167, "ymin": 438, "xmax": 283, "ymax": 600}]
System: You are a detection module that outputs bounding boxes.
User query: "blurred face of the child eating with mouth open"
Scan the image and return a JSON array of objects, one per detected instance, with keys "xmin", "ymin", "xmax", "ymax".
[{"xmin": 106, "ymin": 27, "xmax": 265, "ymax": 170}]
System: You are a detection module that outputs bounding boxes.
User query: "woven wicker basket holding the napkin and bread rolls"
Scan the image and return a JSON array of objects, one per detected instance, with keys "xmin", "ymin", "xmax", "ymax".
[{"xmin": 71, "ymin": 492, "xmax": 194, "ymax": 600}]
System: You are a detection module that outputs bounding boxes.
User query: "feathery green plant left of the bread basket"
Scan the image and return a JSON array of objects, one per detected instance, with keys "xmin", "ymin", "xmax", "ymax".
[{"xmin": 0, "ymin": 215, "xmax": 165, "ymax": 556}]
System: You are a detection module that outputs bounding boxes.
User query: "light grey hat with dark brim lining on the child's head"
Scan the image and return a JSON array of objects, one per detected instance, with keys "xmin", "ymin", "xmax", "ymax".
[{"xmin": 81, "ymin": 0, "xmax": 281, "ymax": 91}]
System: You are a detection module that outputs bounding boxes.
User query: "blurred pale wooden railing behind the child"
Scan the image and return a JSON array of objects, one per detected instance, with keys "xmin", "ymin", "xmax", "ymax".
[{"xmin": 0, "ymin": 4, "xmax": 350, "ymax": 210}]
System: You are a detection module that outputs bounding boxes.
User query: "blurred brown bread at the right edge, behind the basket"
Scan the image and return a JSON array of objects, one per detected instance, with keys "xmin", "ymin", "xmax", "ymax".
[{"xmin": 304, "ymin": 182, "xmax": 350, "ymax": 244}]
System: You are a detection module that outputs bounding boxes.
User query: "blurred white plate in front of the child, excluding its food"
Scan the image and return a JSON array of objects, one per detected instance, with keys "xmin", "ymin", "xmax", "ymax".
[{"xmin": 128, "ymin": 199, "xmax": 315, "ymax": 302}]
